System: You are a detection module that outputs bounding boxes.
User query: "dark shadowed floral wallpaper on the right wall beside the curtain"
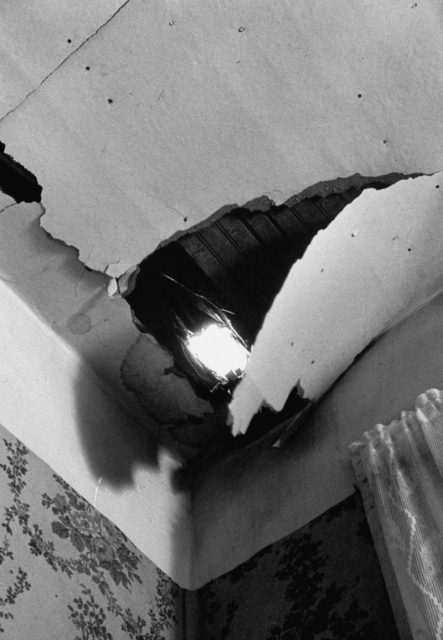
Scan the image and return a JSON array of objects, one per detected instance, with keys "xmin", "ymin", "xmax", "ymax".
[{"xmin": 194, "ymin": 494, "xmax": 399, "ymax": 640}]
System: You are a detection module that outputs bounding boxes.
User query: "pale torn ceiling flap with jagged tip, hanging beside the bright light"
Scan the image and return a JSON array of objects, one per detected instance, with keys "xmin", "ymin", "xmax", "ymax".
[{"xmin": 230, "ymin": 173, "xmax": 443, "ymax": 434}]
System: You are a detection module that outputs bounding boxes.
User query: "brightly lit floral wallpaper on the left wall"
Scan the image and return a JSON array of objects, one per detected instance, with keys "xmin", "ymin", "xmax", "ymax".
[{"xmin": 0, "ymin": 427, "xmax": 183, "ymax": 640}]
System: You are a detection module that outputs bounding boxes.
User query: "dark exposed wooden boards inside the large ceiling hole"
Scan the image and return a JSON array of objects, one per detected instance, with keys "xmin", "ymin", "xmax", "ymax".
[{"xmin": 178, "ymin": 178, "xmax": 395, "ymax": 342}]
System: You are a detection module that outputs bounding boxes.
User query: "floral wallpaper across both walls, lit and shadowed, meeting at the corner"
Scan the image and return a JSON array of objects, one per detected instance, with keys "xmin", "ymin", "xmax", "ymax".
[{"xmin": 0, "ymin": 426, "xmax": 399, "ymax": 640}]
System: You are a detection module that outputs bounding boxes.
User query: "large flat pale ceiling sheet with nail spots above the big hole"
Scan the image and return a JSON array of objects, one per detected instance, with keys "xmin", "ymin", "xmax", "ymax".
[{"xmin": 0, "ymin": 0, "xmax": 443, "ymax": 277}]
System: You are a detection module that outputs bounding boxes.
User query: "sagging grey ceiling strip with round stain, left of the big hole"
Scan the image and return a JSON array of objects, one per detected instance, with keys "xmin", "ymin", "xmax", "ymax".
[{"xmin": 0, "ymin": 199, "xmax": 139, "ymax": 396}]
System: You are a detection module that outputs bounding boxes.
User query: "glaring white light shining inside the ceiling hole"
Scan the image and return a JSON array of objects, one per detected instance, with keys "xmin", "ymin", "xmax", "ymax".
[{"xmin": 186, "ymin": 324, "xmax": 248, "ymax": 378}]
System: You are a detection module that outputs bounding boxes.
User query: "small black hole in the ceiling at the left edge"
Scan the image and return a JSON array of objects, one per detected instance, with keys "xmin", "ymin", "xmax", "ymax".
[{"xmin": 0, "ymin": 141, "xmax": 42, "ymax": 202}]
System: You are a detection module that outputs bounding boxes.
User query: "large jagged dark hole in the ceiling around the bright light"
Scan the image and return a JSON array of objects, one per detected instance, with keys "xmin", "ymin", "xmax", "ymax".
[{"xmin": 126, "ymin": 174, "xmax": 405, "ymax": 460}]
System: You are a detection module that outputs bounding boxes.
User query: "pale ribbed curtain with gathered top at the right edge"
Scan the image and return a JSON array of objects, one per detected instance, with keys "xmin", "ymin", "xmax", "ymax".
[{"xmin": 350, "ymin": 389, "xmax": 443, "ymax": 640}]
